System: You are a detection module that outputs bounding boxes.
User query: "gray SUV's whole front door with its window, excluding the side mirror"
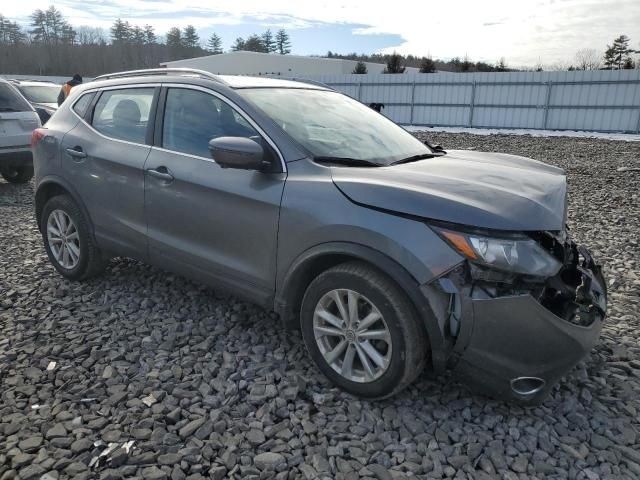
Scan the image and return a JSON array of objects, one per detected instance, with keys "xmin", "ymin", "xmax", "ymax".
[{"xmin": 145, "ymin": 87, "xmax": 286, "ymax": 303}]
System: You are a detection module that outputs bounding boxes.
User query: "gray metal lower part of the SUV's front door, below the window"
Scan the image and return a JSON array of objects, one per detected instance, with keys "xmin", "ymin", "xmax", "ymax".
[{"xmin": 144, "ymin": 148, "xmax": 286, "ymax": 304}]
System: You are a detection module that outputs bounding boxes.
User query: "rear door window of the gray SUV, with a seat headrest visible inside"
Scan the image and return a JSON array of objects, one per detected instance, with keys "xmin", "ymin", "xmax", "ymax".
[{"xmin": 91, "ymin": 88, "xmax": 154, "ymax": 143}]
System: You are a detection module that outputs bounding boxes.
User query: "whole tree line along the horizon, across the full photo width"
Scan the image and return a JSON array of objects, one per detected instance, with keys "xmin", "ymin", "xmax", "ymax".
[{"xmin": 0, "ymin": 6, "xmax": 640, "ymax": 76}]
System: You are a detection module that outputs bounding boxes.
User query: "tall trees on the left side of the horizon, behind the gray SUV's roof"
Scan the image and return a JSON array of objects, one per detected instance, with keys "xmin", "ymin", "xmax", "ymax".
[{"xmin": 0, "ymin": 6, "xmax": 291, "ymax": 76}]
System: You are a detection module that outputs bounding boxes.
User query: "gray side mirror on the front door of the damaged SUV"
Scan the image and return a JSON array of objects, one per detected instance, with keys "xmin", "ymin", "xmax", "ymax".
[{"xmin": 209, "ymin": 137, "xmax": 269, "ymax": 170}]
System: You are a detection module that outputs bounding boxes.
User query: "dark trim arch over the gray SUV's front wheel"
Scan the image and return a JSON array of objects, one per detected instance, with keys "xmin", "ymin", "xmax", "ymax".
[{"xmin": 274, "ymin": 242, "xmax": 446, "ymax": 369}]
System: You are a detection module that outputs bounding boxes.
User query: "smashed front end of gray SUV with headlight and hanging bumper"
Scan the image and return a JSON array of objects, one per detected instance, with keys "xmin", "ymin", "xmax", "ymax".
[{"xmin": 422, "ymin": 231, "xmax": 607, "ymax": 403}]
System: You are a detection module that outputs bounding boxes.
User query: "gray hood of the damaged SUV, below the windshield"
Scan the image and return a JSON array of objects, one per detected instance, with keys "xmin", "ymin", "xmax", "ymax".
[{"xmin": 331, "ymin": 150, "xmax": 567, "ymax": 231}]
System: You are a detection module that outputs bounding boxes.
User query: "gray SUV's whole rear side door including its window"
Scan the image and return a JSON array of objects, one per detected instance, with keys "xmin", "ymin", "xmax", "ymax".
[{"xmin": 62, "ymin": 85, "xmax": 159, "ymax": 260}]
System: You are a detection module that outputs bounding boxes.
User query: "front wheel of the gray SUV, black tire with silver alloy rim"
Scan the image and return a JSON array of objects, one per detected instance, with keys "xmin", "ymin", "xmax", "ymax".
[{"xmin": 300, "ymin": 262, "xmax": 428, "ymax": 399}]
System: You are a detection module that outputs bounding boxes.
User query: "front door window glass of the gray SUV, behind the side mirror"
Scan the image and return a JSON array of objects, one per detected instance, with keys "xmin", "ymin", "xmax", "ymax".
[{"xmin": 162, "ymin": 88, "xmax": 260, "ymax": 158}]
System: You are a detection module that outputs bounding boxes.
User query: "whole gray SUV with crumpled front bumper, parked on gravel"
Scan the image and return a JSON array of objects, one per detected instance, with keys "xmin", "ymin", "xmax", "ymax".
[{"xmin": 34, "ymin": 69, "xmax": 607, "ymax": 402}]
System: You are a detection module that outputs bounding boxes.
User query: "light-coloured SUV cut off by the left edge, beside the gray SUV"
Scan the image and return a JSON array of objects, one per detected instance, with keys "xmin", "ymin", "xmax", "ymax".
[{"xmin": 0, "ymin": 79, "xmax": 40, "ymax": 183}]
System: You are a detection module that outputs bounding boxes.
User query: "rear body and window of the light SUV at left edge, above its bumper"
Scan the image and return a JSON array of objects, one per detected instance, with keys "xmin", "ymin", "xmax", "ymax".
[{"xmin": 0, "ymin": 82, "xmax": 40, "ymax": 154}]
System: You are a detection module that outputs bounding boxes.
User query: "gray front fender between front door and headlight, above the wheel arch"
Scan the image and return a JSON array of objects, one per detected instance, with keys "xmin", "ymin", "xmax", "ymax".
[{"xmin": 277, "ymin": 159, "xmax": 462, "ymax": 285}]
